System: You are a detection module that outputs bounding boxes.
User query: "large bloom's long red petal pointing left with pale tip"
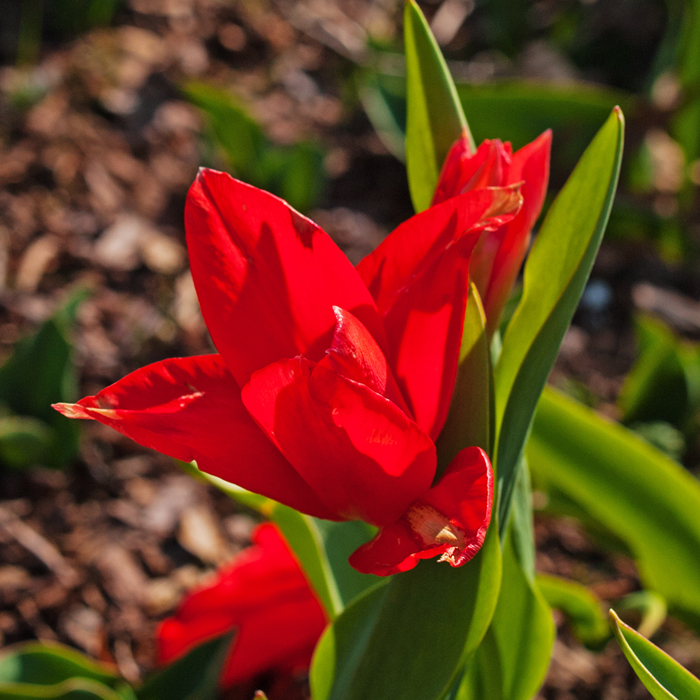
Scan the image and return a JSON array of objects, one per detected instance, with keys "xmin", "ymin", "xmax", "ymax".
[{"xmin": 55, "ymin": 355, "xmax": 333, "ymax": 518}]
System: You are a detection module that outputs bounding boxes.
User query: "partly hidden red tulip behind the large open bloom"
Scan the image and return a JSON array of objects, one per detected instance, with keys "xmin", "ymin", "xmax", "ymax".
[{"xmin": 433, "ymin": 130, "xmax": 552, "ymax": 335}]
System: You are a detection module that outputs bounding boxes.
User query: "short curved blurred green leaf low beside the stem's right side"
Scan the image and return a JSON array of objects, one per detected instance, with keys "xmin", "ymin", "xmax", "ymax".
[{"xmin": 537, "ymin": 574, "xmax": 610, "ymax": 649}]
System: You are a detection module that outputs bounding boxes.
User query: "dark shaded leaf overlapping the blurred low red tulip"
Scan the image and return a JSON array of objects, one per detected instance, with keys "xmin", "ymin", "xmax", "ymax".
[{"xmin": 136, "ymin": 633, "xmax": 233, "ymax": 700}]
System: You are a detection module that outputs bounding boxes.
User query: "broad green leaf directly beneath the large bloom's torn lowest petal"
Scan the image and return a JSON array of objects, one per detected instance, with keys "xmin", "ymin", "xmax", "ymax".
[{"xmin": 311, "ymin": 528, "xmax": 501, "ymax": 700}]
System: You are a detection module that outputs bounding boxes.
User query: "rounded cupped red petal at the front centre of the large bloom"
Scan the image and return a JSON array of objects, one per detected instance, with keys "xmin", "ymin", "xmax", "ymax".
[{"xmin": 242, "ymin": 357, "xmax": 436, "ymax": 525}]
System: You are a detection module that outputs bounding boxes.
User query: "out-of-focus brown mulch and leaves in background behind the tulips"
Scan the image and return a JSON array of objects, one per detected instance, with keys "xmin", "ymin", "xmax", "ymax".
[{"xmin": 0, "ymin": 0, "xmax": 700, "ymax": 700}]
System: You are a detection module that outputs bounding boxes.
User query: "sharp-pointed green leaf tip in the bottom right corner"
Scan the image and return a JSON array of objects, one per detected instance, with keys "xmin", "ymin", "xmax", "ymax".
[{"xmin": 610, "ymin": 610, "xmax": 700, "ymax": 700}]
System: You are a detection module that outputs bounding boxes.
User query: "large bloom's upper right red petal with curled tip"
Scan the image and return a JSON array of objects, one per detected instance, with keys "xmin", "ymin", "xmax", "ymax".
[{"xmin": 358, "ymin": 187, "xmax": 520, "ymax": 440}]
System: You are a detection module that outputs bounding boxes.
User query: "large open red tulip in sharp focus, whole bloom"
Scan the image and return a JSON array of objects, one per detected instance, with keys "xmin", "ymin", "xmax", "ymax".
[{"xmin": 56, "ymin": 170, "xmax": 521, "ymax": 575}]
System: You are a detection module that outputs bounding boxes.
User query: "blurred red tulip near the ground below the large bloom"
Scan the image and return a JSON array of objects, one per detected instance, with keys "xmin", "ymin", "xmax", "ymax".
[{"xmin": 156, "ymin": 523, "xmax": 327, "ymax": 688}]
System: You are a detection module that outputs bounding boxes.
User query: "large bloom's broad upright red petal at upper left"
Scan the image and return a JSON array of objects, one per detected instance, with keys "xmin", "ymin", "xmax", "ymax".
[{"xmin": 185, "ymin": 170, "xmax": 385, "ymax": 386}]
